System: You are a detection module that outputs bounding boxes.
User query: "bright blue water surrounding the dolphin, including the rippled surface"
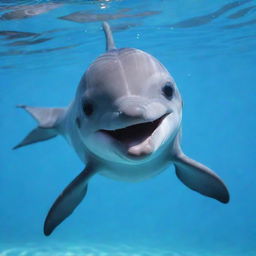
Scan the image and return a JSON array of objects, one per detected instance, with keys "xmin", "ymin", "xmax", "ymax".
[{"xmin": 0, "ymin": 0, "xmax": 256, "ymax": 256}]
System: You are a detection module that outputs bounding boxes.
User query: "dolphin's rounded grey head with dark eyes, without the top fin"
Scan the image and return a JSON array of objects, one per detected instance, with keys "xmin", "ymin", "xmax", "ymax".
[{"xmin": 76, "ymin": 23, "xmax": 182, "ymax": 162}]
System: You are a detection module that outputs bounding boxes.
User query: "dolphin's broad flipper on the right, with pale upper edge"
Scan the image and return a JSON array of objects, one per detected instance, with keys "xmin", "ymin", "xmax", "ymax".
[{"xmin": 174, "ymin": 153, "xmax": 229, "ymax": 203}]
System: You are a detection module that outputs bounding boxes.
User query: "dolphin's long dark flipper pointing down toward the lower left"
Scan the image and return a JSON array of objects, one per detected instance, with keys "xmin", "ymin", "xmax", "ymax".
[{"xmin": 44, "ymin": 166, "xmax": 95, "ymax": 236}]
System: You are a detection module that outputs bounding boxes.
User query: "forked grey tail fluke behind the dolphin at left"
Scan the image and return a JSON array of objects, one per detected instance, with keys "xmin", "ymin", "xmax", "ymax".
[{"xmin": 13, "ymin": 105, "xmax": 65, "ymax": 149}]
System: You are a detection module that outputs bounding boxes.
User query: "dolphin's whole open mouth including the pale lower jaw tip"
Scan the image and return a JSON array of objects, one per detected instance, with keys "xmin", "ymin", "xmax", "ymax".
[{"xmin": 99, "ymin": 114, "xmax": 168, "ymax": 157}]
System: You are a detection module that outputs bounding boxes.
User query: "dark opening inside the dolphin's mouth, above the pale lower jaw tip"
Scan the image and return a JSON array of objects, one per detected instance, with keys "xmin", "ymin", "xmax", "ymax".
[{"xmin": 100, "ymin": 114, "xmax": 166, "ymax": 146}]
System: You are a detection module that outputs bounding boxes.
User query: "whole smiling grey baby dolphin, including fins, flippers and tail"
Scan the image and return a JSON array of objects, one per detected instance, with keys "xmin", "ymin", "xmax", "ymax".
[{"xmin": 14, "ymin": 22, "xmax": 229, "ymax": 236}]
